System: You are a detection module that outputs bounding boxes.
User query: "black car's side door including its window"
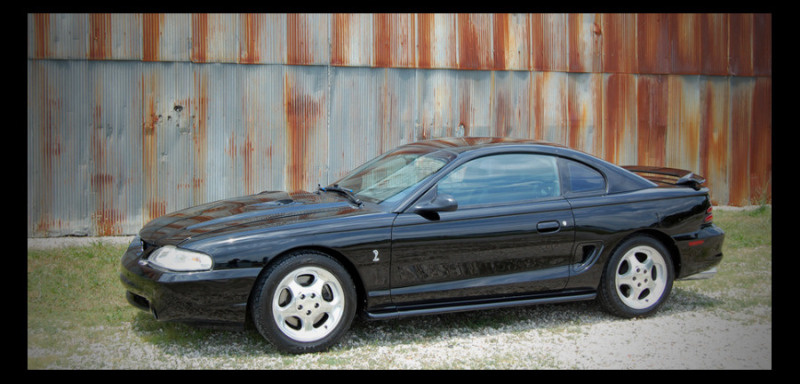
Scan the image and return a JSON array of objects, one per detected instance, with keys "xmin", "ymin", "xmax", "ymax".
[{"xmin": 391, "ymin": 153, "xmax": 574, "ymax": 305}]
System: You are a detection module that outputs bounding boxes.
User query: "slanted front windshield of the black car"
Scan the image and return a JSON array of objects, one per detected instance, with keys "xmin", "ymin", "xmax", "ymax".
[{"xmin": 334, "ymin": 146, "xmax": 455, "ymax": 204}]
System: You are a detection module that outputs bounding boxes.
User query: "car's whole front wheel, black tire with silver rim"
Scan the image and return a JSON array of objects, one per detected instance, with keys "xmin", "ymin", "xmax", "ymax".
[{"xmin": 251, "ymin": 251, "xmax": 356, "ymax": 353}]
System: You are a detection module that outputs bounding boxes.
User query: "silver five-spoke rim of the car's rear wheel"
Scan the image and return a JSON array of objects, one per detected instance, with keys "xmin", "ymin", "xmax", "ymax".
[{"xmin": 614, "ymin": 245, "xmax": 668, "ymax": 309}]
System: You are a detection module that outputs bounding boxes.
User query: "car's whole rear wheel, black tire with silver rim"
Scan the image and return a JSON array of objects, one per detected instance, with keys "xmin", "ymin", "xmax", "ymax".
[{"xmin": 597, "ymin": 235, "xmax": 675, "ymax": 318}]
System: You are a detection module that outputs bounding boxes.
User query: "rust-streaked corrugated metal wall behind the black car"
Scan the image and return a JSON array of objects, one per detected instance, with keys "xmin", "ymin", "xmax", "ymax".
[{"xmin": 27, "ymin": 14, "xmax": 772, "ymax": 236}]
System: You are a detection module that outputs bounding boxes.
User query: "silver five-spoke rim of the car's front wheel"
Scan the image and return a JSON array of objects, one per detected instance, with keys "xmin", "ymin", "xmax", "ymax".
[{"xmin": 272, "ymin": 267, "xmax": 345, "ymax": 342}]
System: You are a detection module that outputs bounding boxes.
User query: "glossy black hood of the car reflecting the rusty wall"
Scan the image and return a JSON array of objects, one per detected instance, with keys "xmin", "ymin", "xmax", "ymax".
[{"xmin": 139, "ymin": 191, "xmax": 374, "ymax": 245}]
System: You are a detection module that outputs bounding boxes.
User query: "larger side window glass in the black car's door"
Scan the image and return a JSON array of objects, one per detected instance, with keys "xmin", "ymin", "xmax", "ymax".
[{"xmin": 438, "ymin": 154, "xmax": 561, "ymax": 207}]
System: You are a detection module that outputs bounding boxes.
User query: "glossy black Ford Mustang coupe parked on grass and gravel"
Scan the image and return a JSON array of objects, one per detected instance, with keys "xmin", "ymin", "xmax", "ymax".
[{"xmin": 120, "ymin": 138, "xmax": 724, "ymax": 353}]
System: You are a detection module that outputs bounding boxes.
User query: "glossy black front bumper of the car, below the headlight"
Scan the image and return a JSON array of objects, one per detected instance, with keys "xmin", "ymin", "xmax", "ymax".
[{"xmin": 120, "ymin": 237, "xmax": 261, "ymax": 324}]
